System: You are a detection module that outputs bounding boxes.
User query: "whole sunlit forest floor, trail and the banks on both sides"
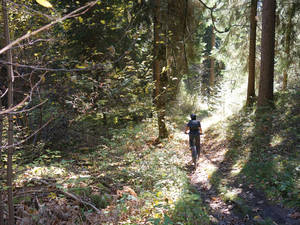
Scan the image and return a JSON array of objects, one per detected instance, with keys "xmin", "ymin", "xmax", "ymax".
[{"xmin": 3, "ymin": 87, "xmax": 300, "ymax": 225}]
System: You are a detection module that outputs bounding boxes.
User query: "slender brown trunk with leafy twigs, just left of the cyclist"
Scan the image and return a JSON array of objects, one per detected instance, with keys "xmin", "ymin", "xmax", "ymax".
[{"xmin": 153, "ymin": 0, "xmax": 168, "ymax": 139}]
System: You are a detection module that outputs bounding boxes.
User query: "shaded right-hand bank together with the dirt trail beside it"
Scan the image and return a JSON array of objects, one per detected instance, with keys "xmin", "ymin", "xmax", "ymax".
[{"xmin": 191, "ymin": 86, "xmax": 300, "ymax": 225}]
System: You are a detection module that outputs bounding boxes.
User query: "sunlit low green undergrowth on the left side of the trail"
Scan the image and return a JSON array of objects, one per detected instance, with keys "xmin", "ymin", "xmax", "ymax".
[{"xmin": 15, "ymin": 120, "xmax": 209, "ymax": 225}]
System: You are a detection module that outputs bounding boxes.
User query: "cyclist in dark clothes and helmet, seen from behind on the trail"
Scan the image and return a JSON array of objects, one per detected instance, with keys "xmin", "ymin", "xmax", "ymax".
[{"xmin": 185, "ymin": 114, "xmax": 203, "ymax": 157}]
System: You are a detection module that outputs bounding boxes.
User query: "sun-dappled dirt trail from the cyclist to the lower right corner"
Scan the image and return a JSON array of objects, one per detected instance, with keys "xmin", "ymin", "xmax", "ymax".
[{"xmin": 178, "ymin": 128, "xmax": 300, "ymax": 225}]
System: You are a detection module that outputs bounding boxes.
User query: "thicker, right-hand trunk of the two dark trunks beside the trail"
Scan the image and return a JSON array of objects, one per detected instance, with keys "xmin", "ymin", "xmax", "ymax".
[{"xmin": 258, "ymin": 0, "xmax": 276, "ymax": 108}]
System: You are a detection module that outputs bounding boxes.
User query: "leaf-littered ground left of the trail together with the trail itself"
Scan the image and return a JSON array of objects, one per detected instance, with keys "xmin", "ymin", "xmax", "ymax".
[{"xmin": 9, "ymin": 119, "xmax": 300, "ymax": 225}]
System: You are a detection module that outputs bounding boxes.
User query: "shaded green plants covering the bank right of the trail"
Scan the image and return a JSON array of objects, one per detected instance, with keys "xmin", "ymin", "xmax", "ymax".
[{"xmin": 227, "ymin": 85, "xmax": 300, "ymax": 208}]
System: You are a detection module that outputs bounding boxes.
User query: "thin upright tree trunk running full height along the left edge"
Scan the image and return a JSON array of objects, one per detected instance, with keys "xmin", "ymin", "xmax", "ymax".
[{"xmin": 2, "ymin": 0, "xmax": 15, "ymax": 225}]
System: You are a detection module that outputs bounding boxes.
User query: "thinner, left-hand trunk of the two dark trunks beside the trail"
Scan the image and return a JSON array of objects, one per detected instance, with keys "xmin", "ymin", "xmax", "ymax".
[{"xmin": 246, "ymin": 0, "xmax": 257, "ymax": 106}]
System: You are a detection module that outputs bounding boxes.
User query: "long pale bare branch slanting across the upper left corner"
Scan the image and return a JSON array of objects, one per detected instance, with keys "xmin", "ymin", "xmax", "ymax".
[{"xmin": 0, "ymin": 0, "xmax": 99, "ymax": 54}]
